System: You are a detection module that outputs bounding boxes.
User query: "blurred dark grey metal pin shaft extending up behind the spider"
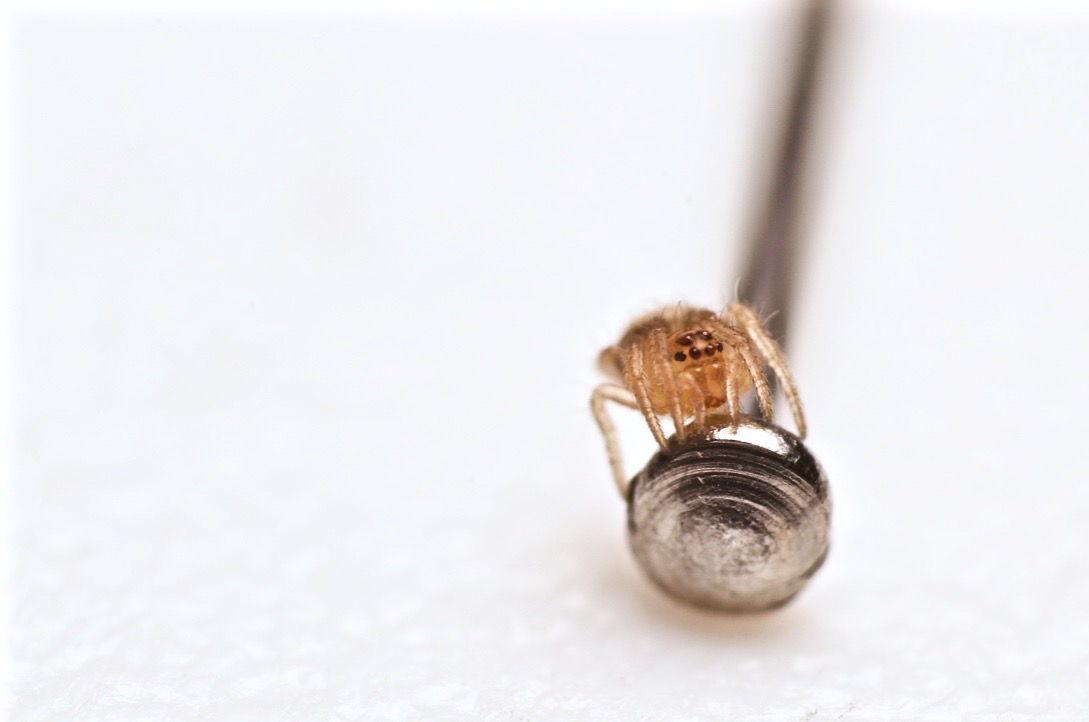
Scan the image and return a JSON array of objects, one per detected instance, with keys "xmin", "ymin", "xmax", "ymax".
[{"xmin": 737, "ymin": 0, "xmax": 833, "ymax": 344}]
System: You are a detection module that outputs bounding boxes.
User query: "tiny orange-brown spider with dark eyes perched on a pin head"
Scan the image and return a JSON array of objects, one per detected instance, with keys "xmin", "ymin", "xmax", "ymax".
[{"xmin": 590, "ymin": 303, "xmax": 806, "ymax": 497}]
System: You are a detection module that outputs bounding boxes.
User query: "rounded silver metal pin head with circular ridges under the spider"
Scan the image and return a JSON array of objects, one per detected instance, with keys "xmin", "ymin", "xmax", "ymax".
[{"xmin": 627, "ymin": 417, "xmax": 831, "ymax": 612}]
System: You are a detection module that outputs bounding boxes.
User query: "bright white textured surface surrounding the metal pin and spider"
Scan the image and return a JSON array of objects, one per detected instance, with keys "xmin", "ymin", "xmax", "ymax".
[{"xmin": 12, "ymin": 10, "xmax": 1089, "ymax": 722}]
